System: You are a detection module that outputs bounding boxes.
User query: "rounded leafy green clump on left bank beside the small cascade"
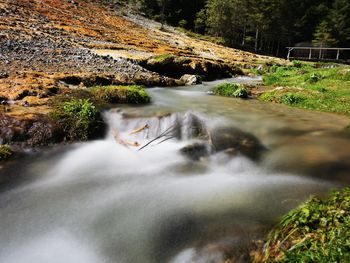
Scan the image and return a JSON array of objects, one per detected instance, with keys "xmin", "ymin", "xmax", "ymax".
[{"xmin": 51, "ymin": 99, "xmax": 104, "ymax": 141}]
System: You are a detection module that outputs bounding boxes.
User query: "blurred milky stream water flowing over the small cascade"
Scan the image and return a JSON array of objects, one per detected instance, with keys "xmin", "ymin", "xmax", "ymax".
[{"xmin": 0, "ymin": 78, "xmax": 350, "ymax": 263}]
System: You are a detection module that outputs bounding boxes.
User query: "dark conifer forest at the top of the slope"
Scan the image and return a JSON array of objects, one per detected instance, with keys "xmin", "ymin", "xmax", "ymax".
[{"xmin": 125, "ymin": 0, "xmax": 350, "ymax": 56}]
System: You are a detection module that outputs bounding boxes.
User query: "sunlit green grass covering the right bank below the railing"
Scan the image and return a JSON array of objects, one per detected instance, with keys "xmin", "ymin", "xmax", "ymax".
[{"xmin": 260, "ymin": 61, "xmax": 350, "ymax": 115}]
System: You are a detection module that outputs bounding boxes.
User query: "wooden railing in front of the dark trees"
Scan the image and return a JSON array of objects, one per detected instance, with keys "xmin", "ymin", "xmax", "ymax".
[{"xmin": 286, "ymin": 47, "xmax": 350, "ymax": 60}]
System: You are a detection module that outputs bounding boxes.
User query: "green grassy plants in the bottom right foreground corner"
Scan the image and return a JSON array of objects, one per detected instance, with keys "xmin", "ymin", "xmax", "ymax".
[{"xmin": 265, "ymin": 188, "xmax": 350, "ymax": 263}]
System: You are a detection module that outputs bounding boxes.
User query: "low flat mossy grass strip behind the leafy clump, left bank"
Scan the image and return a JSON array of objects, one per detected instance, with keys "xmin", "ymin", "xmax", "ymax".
[{"xmin": 91, "ymin": 85, "xmax": 151, "ymax": 104}]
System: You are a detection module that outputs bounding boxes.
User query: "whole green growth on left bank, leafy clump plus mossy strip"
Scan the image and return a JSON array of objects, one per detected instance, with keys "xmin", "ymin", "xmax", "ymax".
[{"xmin": 51, "ymin": 85, "xmax": 151, "ymax": 141}]
